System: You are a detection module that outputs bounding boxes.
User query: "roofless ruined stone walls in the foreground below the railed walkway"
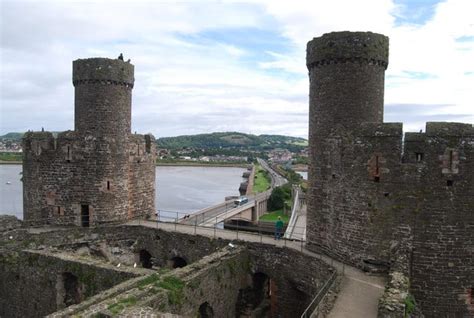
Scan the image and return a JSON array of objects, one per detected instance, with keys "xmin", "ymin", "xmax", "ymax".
[{"xmin": 0, "ymin": 226, "xmax": 333, "ymax": 317}]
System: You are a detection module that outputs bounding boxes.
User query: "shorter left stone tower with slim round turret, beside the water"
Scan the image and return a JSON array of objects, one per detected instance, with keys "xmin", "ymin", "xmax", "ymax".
[{"xmin": 23, "ymin": 58, "xmax": 156, "ymax": 226}]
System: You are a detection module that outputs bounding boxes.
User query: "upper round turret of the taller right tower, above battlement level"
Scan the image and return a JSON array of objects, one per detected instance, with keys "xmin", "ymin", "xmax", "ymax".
[{"xmin": 306, "ymin": 32, "xmax": 388, "ymax": 138}]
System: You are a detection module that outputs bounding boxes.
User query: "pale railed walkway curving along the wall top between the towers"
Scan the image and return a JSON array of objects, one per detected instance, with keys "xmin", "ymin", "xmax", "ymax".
[{"xmin": 127, "ymin": 220, "xmax": 385, "ymax": 318}]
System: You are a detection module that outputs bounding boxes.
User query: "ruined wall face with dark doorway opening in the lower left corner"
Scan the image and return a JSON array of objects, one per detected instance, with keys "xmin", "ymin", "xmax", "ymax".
[{"xmin": 0, "ymin": 251, "xmax": 138, "ymax": 317}]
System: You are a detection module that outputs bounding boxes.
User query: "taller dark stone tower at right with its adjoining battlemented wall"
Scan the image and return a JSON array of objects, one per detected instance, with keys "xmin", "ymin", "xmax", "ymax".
[{"xmin": 307, "ymin": 32, "xmax": 474, "ymax": 317}]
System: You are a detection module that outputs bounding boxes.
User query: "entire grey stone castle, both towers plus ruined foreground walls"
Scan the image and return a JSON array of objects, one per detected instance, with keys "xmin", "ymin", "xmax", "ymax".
[{"xmin": 0, "ymin": 32, "xmax": 474, "ymax": 318}]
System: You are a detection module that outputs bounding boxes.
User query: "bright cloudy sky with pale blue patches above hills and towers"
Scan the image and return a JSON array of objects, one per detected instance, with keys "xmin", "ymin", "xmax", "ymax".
[{"xmin": 0, "ymin": 0, "xmax": 474, "ymax": 138}]
